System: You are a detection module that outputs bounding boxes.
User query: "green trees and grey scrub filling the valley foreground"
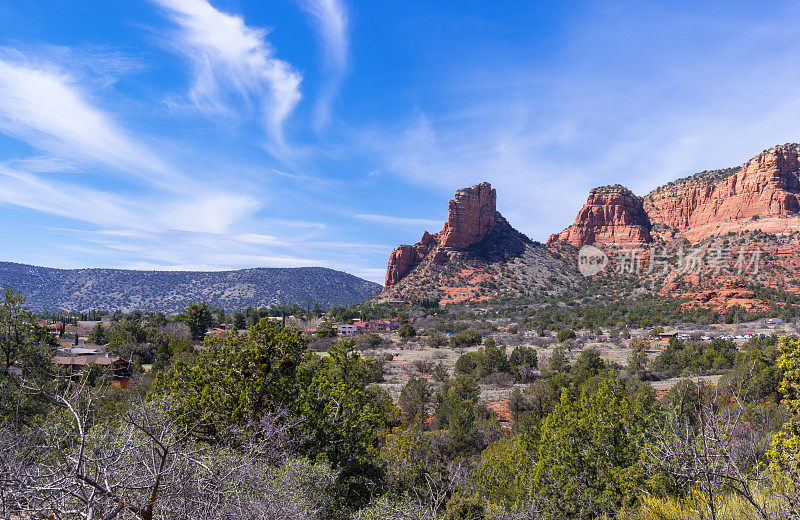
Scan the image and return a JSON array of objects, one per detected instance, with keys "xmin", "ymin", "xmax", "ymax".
[{"xmin": 0, "ymin": 291, "xmax": 800, "ymax": 520}]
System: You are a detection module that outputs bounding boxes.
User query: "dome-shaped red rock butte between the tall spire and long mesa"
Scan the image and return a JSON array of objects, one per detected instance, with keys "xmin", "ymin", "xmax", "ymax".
[{"xmin": 547, "ymin": 185, "xmax": 652, "ymax": 247}]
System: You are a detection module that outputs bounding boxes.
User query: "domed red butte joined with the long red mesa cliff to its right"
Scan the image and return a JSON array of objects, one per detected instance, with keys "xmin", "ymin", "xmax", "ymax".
[{"xmin": 548, "ymin": 144, "xmax": 800, "ymax": 247}]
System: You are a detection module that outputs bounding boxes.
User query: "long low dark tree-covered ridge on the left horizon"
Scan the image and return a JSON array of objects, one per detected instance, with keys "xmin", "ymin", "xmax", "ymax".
[{"xmin": 0, "ymin": 262, "xmax": 381, "ymax": 313}]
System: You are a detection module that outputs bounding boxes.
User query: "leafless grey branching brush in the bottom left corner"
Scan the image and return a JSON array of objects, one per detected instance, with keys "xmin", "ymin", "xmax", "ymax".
[{"xmin": 0, "ymin": 376, "xmax": 318, "ymax": 520}]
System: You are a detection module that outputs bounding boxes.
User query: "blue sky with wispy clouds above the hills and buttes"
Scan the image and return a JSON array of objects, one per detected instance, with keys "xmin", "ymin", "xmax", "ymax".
[{"xmin": 0, "ymin": 0, "xmax": 800, "ymax": 281}]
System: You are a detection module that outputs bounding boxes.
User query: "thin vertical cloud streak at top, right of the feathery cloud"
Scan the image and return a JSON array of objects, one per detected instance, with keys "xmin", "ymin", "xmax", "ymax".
[{"xmin": 298, "ymin": 0, "xmax": 350, "ymax": 128}]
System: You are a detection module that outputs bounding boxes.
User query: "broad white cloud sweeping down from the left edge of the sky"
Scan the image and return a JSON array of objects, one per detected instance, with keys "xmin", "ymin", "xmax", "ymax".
[{"xmin": 0, "ymin": 44, "xmax": 276, "ymax": 252}]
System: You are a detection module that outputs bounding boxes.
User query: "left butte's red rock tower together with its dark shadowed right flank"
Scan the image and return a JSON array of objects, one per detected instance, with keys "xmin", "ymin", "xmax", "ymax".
[{"xmin": 386, "ymin": 182, "xmax": 530, "ymax": 288}]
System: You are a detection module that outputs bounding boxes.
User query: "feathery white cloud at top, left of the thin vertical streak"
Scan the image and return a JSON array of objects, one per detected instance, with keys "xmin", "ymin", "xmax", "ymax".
[{"xmin": 152, "ymin": 0, "xmax": 302, "ymax": 145}]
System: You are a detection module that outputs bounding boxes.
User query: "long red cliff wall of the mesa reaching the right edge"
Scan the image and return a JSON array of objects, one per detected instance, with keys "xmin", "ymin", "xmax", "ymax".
[{"xmin": 644, "ymin": 144, "xmax": 800, "ymax": 241}]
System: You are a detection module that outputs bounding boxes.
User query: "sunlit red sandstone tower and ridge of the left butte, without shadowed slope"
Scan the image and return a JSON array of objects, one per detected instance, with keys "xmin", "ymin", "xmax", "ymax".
[{"xmin": 385, "ymin": 182, "xmax": 503, "ymax": 288}]
